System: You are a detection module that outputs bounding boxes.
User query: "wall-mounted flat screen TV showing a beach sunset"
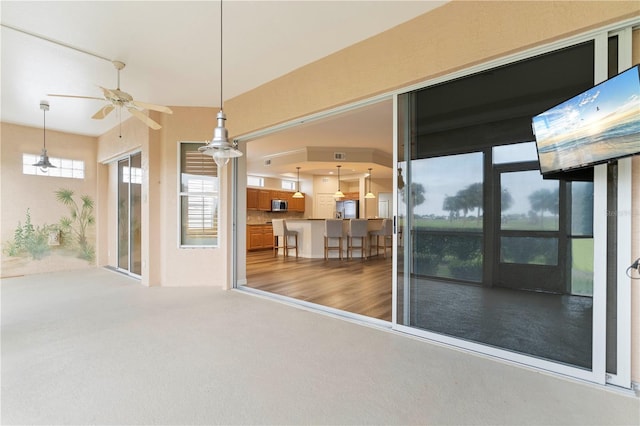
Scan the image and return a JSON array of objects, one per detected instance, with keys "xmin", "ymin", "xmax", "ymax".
[{"xmin": 533, "ymin": 65, "xmax": 640, "ymax": 175}]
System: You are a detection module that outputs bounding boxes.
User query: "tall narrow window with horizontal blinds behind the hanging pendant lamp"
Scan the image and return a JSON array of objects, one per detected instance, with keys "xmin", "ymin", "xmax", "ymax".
[{"xmin": 179, "ymin": 143, "xmax": 219, "ymax": 247}]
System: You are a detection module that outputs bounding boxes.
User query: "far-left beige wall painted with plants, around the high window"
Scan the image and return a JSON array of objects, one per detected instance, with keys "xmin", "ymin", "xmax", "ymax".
[{"xmin": 0, "ymin": 123, "xmax": 98, "ymax": 276}]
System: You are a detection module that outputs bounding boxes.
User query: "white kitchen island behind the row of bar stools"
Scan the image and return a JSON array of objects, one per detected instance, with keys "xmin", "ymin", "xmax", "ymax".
[{"xmin": 278, "ymin": 219, "xmax": 382, "ymax": 259}]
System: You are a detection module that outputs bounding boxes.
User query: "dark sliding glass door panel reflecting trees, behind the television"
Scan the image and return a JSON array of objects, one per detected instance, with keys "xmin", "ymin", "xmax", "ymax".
[{"xmin": 396, "ymin": 38, "xmax": 606, "ymax": 380}]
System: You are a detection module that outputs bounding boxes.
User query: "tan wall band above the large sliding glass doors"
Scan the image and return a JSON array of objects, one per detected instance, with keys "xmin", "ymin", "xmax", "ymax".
[{"xmin": 225, "ymin": 1, "xmax": 639, "ymax": 135}]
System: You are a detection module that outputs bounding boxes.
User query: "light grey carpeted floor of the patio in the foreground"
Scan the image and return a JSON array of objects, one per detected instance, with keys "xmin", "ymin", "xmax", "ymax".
[{"xmin": 1, "ymin": 269, "xmax": 640, "ymax": 425}]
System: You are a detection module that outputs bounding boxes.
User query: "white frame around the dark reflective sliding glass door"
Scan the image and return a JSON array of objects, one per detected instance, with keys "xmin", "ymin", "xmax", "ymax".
[{"xmin": 392, "ymin": 24, "xmax": 638, "ymax": 388}]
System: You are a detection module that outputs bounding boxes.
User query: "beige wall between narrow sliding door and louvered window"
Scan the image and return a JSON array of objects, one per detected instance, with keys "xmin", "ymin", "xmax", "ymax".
[{"xmin": 98, "ymin": 107, "xmax": 228, "ymax": 287}]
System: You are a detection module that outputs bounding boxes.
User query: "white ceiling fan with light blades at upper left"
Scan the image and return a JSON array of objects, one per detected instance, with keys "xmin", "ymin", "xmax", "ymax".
[{"xmin": 47, "ymin": 61, "xmax": 173, "ymax": 130}]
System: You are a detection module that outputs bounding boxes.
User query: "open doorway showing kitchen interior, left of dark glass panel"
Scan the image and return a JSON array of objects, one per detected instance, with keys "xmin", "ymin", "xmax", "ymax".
[{"xmin": 238, "ymin": 97, "xmax": 395, "ymax": 322}]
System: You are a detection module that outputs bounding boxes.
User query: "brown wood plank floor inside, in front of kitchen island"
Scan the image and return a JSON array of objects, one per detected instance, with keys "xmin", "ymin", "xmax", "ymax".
[{"xmin": 247, "ymin": 250, "xmax": 392, "ymax": 321}]
